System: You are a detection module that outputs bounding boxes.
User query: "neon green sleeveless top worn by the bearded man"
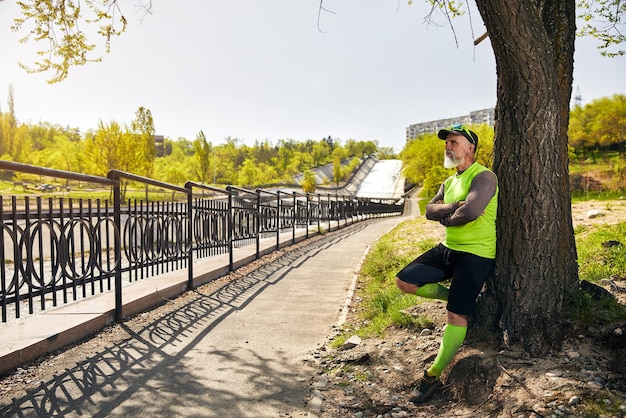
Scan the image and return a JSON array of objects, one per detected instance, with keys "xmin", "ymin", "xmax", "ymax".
[{"xmin": 443, "ymin": 163, "xmax": 498, "ymax": 259}]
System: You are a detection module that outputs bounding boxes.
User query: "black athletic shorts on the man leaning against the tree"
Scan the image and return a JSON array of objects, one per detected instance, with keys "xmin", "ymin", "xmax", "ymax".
[{"xmin": 397, "ymin": 244, "xmax": 495, "ymax": 316}]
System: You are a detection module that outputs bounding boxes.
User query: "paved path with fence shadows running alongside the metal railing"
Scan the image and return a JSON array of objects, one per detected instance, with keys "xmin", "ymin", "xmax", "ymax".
[{"xmin": 0, "ymin": 217, "xmax": 406, "ymax": 418}]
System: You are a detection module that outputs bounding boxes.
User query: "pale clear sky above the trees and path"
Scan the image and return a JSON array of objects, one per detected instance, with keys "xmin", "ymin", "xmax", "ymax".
[{"xmin": 0, "ymin": 0, "xmax": 626, "ymax": 151}]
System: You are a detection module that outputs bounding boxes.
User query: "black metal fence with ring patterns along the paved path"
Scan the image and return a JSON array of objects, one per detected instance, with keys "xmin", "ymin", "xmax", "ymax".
[{"xmin": 0, "ymin": 160, "xmax": 403, "ymax": 322}]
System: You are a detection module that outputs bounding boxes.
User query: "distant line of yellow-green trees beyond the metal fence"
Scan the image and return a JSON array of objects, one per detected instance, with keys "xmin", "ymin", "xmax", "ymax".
[{"xmin": 0, "ymin": 88, "xmax": 395, "ymax": 189}]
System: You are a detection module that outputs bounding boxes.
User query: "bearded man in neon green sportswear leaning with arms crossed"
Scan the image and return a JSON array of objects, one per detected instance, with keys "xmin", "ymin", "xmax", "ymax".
[{"xmin": 396, "ymin": 125, "xmax": 498, "ymax": 404}]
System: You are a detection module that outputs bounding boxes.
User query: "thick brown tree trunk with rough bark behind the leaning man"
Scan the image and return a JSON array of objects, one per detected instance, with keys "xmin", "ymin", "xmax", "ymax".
[{"xmin": 475, "ymin": 0, "xmax": 578, "ymax": 355}]
